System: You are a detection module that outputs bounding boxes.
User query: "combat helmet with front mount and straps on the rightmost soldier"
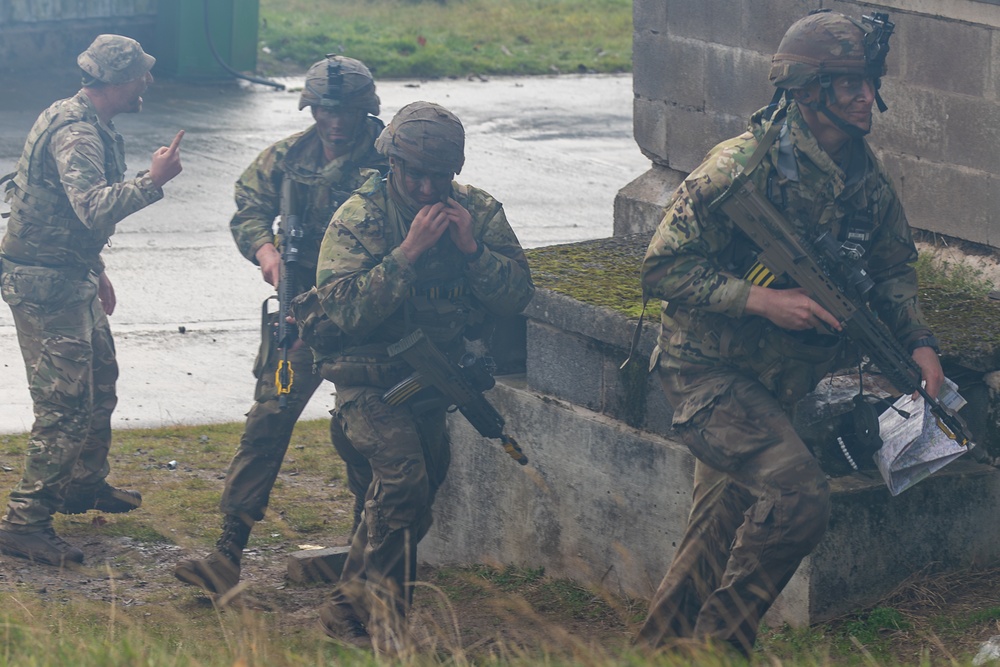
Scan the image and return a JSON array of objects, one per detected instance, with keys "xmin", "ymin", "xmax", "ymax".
[{"xmin": 768, "ymin": 9, "xmax": 895, "ymax": 128}]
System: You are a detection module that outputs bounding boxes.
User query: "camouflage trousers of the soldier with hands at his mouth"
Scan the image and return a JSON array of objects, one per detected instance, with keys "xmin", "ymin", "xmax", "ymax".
[{"xmin": 332, "ymin": 387, "xmax": 451, "ymax": 638}]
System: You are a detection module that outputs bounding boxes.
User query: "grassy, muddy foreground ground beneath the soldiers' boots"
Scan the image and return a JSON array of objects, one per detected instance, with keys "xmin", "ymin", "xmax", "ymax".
[{"xmin": 0, "ymin": 421, "xmax": 1000, "ymax": 667}]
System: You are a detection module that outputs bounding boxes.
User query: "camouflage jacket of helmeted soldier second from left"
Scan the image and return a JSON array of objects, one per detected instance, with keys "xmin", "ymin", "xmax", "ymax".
[{"xmin": 229, "ymin": 116, "xmax": 388, "ymax": 291}]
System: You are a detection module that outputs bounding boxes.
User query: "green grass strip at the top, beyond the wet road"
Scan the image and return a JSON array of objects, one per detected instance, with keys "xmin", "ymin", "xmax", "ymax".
[{"xmin": 259, "ymin": 0, "xmax": 632, "ymax": 78}]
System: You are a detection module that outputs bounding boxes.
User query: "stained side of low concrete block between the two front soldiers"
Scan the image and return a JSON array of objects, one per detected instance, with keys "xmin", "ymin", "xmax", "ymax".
[{"xmin": 420, "ymin": 380, "xmax": 694, "ymax": 596}]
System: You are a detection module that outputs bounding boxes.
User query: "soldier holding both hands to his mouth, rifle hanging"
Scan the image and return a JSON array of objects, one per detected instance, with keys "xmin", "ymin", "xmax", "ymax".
[{"xmin": 316, "ymin": 102, "xmax": 534, "ymax": 646}]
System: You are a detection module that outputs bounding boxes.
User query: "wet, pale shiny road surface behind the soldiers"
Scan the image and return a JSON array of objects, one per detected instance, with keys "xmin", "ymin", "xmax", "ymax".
[{"xmin": 0, "ymin": 75, "xmax": 649, "ymax": 433}]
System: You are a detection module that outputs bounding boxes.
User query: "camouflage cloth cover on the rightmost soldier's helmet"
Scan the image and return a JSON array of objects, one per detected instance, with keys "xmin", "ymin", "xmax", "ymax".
[{"xmin": 768, "ymin": 11, "xmax": 885, "ymax": 90}]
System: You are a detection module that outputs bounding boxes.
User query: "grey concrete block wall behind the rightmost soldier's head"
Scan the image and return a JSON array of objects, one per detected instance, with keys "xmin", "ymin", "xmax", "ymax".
[{"xmin": 615, "ymin": 0, "xmax": 1000, "ymax": 247}]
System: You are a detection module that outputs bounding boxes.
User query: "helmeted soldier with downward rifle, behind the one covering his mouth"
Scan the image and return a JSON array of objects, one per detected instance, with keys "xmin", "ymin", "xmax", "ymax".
[{"xmin": 174, "ymin": 55, "xmax": 388, "ymax": 594}]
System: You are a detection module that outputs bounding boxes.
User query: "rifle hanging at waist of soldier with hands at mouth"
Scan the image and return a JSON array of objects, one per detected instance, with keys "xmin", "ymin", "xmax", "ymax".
[{"xmin": 382, "ymin": 329, "xmax": 528, "ymax": 465}]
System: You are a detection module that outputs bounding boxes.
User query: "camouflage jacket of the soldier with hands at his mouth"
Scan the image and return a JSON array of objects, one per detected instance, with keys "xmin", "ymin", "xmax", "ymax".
[{"xmin": 317, "ymin": 177, "xmax": 535, "ymax": 387}]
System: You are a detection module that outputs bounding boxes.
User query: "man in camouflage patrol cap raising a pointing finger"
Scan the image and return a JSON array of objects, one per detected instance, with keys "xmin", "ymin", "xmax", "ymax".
[{"xmin": 0, "ymin": 35, "xmax": 183, "ymax": 565}]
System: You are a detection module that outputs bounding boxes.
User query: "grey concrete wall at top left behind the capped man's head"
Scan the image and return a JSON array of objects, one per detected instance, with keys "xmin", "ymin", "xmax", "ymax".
[{"xmin": 0, "ymin": 0, "xmax": 157, "ymax": 74}]
